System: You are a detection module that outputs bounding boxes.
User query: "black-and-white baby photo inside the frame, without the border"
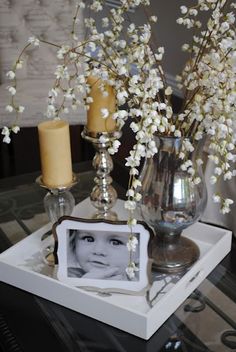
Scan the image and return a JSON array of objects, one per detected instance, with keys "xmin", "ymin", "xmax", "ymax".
[{"xmin": 67, "ymin": 229, "xmax": 139, "ymax": 280}]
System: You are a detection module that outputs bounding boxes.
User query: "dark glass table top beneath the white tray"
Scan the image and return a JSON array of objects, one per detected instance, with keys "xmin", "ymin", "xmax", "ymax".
[{"xmin": 0, "ymin": 165, "xmax": 236, "ymax": 352}]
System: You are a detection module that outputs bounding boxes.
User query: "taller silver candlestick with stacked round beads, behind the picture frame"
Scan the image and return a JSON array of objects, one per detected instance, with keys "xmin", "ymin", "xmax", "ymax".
[{"xmin": 81, "ymin": 127, "xmax": 122, "ymax": 221}]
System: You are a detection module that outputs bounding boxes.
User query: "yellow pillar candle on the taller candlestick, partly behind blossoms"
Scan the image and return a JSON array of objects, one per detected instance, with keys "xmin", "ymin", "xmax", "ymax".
[{"xmin": 87, "ymin": 76, "xmax": 116, "ymax": 132}]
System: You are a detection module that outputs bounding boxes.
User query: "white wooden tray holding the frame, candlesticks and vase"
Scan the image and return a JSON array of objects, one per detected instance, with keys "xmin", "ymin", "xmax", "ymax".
[{"xmin": 0, "ymin": 199, "xmax": 232, "ymax": 339}]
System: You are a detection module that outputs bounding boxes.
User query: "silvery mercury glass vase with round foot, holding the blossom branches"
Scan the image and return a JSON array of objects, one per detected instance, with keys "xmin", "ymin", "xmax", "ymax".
[{"xmin": 141, "ymin": 136, "xmax": 207, "ymax": 273}]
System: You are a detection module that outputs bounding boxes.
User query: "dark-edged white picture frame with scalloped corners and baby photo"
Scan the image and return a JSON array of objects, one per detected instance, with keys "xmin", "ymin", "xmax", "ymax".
[{"xmin": 53, "ymin": 216, "xmax": 152, "ymax": 294}]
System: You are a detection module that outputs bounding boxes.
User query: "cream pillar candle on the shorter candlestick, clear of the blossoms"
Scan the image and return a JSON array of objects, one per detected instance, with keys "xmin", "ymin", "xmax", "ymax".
[{"xmin": 38, "ymin": 120, "xmax": 72, "ymax": 188}]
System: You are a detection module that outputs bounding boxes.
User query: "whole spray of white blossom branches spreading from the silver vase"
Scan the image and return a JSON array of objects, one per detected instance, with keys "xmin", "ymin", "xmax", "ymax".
[{"xmin": 4, "ymin": 0, "xmax": 236, "ymax": 217}]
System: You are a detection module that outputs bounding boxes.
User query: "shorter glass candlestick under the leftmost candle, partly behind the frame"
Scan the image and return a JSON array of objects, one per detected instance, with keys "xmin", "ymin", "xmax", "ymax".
[{"xmin": 36, "ymin": 174, "xmax": 78, "ymax": 266}]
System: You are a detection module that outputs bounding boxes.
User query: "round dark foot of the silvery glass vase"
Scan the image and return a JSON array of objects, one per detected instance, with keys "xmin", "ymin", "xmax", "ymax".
[{"xmin": 151, "ymin": 236, "xmax": 200, "ymax": 274}]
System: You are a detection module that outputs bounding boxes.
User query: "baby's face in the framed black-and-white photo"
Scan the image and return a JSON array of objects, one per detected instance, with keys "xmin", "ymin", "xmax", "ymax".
[{"xmin": 75, "ymin": 231, "xmax": 132, "ymax": 275}]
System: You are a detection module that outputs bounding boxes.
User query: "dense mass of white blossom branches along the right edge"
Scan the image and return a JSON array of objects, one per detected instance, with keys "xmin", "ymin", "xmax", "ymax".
[{"xmin": 177, "ymin": 0, "xmax": 236, "ymax": 213}]
